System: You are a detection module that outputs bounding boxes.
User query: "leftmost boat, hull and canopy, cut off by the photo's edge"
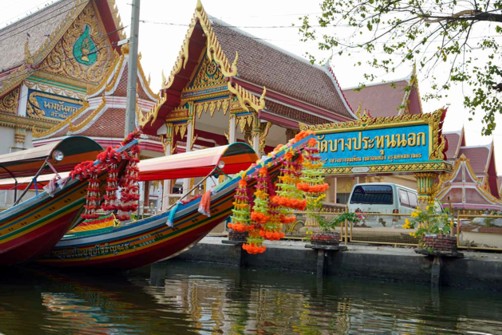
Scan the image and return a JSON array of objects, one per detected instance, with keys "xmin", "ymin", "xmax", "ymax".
[{"xmin": 0, "ymin": 136, "xmax": 102, "ymax": 265}]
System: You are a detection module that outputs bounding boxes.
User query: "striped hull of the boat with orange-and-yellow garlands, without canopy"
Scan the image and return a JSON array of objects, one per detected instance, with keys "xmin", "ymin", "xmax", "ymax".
[{"xmin": 39, "ymin": 178, "xmax": 238, "ymax": 270}]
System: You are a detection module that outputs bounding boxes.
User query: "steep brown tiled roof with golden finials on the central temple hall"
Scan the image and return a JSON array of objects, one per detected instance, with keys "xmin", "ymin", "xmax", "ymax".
[{"xmin": 142, "ymin": 2, "xmax": 356, "ymax": 134}]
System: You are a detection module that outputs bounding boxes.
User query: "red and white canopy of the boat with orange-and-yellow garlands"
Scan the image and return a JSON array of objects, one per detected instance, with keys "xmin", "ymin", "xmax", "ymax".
[{"xmin": 138, "ymin": 142, "xmax": 258, "ymax": 181}]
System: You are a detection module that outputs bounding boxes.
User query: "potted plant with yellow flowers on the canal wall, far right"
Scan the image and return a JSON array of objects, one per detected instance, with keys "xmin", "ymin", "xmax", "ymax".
[{"xmin": 403, "ymin": 205, "xmax": 457, "ymax": 254}]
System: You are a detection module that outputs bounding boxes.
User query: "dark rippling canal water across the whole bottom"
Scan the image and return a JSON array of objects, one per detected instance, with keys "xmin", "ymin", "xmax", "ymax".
[{"xmin": 0, "ymin": 261, "xmax": 502, "ymax": 335}]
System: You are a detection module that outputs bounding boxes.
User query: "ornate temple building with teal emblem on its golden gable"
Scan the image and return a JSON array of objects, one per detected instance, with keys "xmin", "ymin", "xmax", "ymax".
[{"xmin": 0, "ymin": 0, "xmax": 163, "ymax": 207}]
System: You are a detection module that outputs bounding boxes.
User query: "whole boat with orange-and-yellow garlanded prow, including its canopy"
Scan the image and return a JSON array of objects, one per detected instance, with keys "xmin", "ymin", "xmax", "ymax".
[{"xmin": 40, "ymin": 137, "xmax": 310, "ymax": 269}]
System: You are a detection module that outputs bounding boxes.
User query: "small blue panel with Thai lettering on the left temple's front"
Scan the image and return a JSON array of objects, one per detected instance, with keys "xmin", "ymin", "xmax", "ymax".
[{"xmin": 26, "ymin": 89, "xmax": 83, "ymax": 120}]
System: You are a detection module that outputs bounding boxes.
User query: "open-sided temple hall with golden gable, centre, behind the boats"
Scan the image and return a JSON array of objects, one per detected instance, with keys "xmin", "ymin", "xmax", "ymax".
[{"xmin": 140, "ymin": 2, "xmax": 356, "ymax": 207}]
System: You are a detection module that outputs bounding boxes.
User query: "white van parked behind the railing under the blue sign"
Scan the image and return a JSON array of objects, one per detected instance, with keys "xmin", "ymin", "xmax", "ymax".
[{"xmin": 347, "ymin": 183, "xmax": 418, "ymax": 227}]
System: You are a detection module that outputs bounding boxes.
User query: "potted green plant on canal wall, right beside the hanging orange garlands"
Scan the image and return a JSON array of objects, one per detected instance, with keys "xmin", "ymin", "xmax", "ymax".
[{"xmin": 310, "ymin": 212, "xmax": 360, "ymax": 245}]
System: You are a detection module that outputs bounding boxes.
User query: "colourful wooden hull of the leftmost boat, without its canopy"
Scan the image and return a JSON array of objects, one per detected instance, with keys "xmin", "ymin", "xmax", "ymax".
[{"xmin": 0, "ymin": 180, "xmax": 87, "ymax": 265}]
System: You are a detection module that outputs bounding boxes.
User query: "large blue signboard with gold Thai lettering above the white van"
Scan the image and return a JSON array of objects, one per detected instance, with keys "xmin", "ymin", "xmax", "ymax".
[{"xmin": 317, "ymin": 124, "xmax": 431, "ymax": 172}]
